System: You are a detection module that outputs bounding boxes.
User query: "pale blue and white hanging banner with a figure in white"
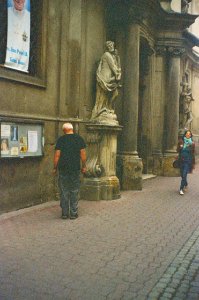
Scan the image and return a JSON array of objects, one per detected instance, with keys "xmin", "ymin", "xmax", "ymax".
[{"xmin": 4, "ymin": 0, "xmax": 30, "ymax": 72}]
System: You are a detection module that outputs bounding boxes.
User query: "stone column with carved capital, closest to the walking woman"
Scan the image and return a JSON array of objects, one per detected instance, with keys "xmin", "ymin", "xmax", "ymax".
[{"xmin": 163, "ymin": 47, "xmax": 184, "ymax": 176}]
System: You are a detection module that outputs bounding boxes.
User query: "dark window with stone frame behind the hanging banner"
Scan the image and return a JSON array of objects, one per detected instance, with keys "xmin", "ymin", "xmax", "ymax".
[{"xmin": 0, "ymin": 0, "xmax": 47, "ymax": 87}]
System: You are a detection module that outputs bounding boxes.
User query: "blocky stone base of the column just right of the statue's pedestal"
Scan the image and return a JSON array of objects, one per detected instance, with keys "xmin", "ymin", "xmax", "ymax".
[{"xmin": 117, "ymin": 154, "xmax": 143, "ymax": 190}]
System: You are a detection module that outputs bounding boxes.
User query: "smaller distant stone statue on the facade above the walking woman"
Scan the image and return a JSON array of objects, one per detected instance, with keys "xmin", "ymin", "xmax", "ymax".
[{"xmin": 180, "ymin": 76, "xmax": 194, "ymax": 129}]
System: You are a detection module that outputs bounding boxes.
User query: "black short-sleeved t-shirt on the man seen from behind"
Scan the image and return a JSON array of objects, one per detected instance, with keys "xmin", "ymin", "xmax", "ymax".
[{"xmin": 55, "ymin": 133, "xmax": 86, "ymax": 174}]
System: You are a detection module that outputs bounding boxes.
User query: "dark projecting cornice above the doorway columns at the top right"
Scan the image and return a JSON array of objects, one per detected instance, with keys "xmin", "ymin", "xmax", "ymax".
[{"xmin": 105, "ymin": 0, "xmax": 198, "ymax": 32}]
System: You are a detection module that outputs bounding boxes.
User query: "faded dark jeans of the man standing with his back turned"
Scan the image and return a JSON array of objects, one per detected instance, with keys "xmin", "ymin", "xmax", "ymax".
[{"xmin": 59, "ymin": 171, "xmax": 80, "ymax": 216}]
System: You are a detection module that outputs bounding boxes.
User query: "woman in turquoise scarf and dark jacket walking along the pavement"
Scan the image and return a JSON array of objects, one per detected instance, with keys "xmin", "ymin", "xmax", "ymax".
[{"xmin": 177, "ymin": 130, "xmax": 195, "ymax": 195}]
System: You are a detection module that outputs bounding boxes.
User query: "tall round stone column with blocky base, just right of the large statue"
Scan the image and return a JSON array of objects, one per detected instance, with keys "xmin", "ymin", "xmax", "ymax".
[{"xmin": 118, "ymin": 24, "xmax": 142, "ymax": 190}]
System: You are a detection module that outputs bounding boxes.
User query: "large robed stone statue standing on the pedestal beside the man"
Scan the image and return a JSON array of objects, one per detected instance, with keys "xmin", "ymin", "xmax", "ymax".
[{"xmin": 91, "ymin": 41, "xmax": 121, "ymax": 124}]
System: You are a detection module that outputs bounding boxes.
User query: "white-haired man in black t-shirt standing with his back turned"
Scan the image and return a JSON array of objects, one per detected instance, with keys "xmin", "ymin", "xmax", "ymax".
[{"xmin": 54, "ymin": 123, "xmax": 86, "ymax": 219}]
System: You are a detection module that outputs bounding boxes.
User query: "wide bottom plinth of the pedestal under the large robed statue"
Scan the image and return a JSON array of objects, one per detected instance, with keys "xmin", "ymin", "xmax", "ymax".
[{"xmin": 80, "ymin": 176, "xmax": 121, "ymax": 201}]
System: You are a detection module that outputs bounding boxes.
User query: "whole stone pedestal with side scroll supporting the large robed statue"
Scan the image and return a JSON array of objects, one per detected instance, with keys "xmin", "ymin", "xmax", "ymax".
[{"xmin": 80, "ymin": 123, "xmax": 122, "ymax": 200}]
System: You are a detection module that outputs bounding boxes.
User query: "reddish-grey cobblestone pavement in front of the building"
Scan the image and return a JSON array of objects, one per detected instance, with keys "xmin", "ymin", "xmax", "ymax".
[{"xmin": 0, "ymin": 164, "xmax": 199, "ymax": 300}]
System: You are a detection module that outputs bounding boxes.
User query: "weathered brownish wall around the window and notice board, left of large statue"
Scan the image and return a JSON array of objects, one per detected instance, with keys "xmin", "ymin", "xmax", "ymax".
[{"xmin": 0, "ymin": 0, "xmax": 105, "ymax": 213}]
